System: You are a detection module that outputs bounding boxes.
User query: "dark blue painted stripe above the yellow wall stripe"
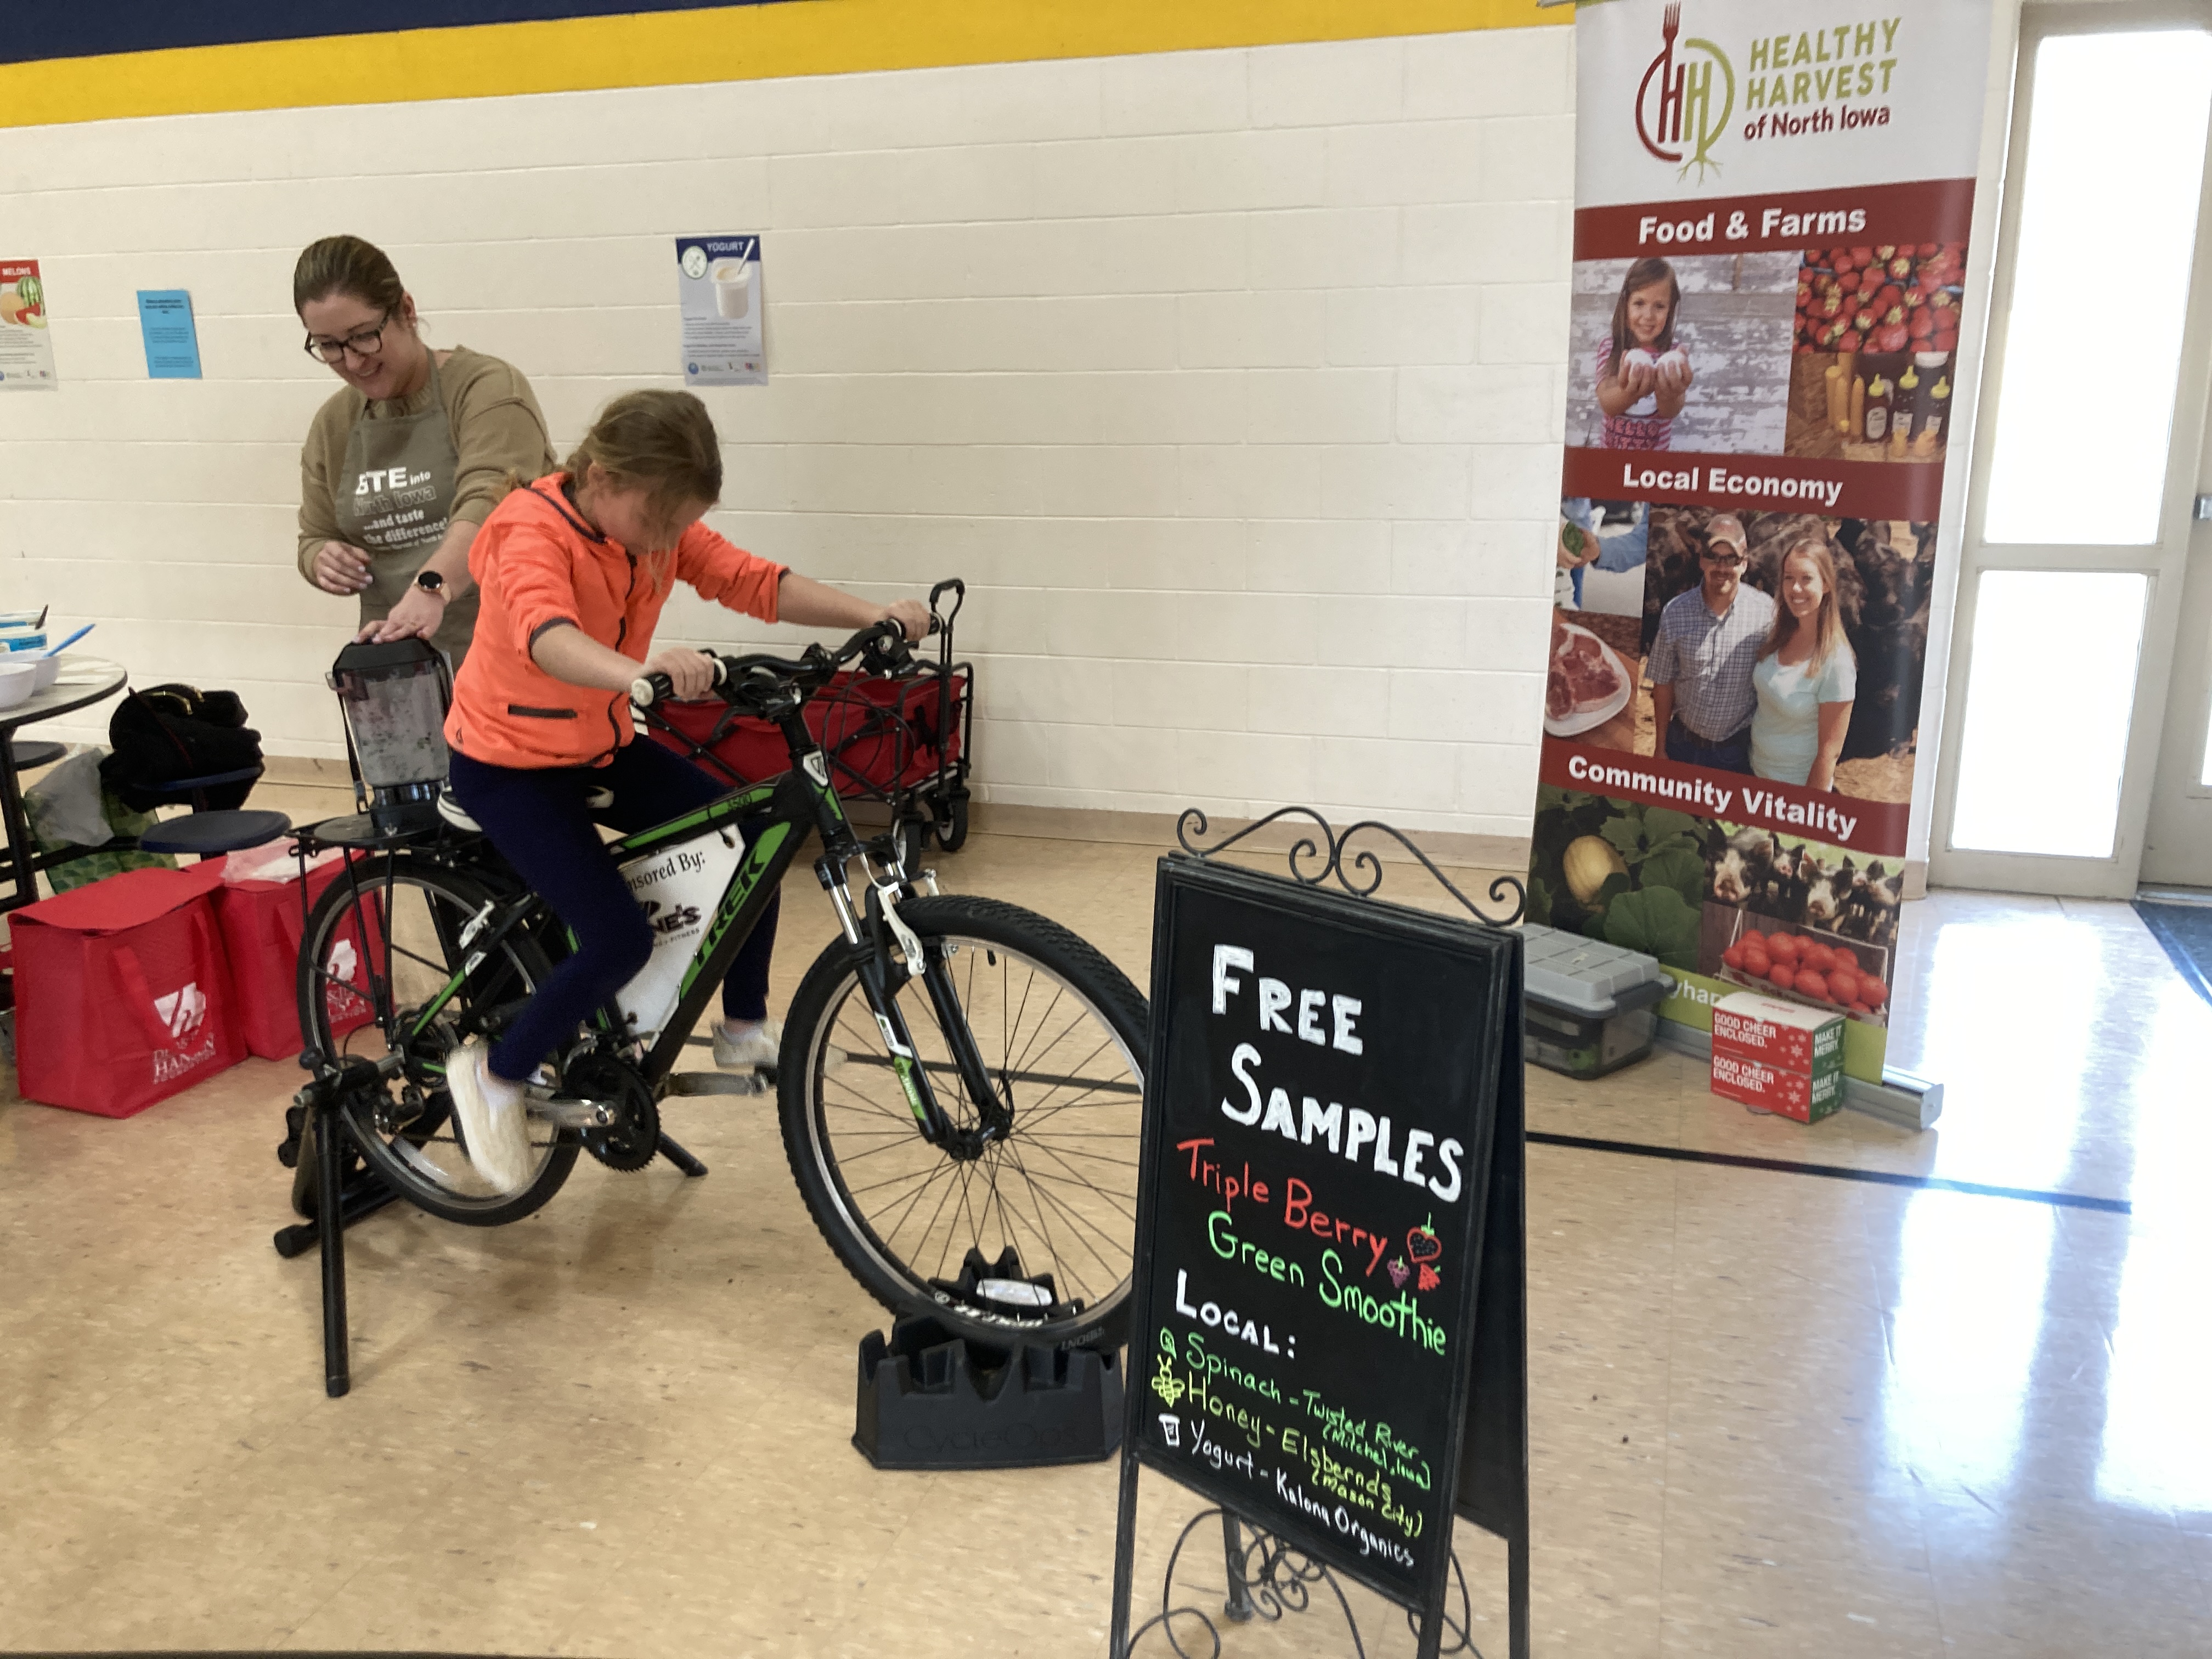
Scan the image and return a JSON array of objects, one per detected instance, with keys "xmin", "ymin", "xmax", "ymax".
[{"xmin": 0, "ymin": 0, "xmax": 781, "ymax": 67}]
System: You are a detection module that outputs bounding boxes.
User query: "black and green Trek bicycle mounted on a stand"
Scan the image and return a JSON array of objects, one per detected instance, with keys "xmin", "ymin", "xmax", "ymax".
[{"xmin": 298, "ymin": 622, "xmax": 1148, "ymax": 1345}]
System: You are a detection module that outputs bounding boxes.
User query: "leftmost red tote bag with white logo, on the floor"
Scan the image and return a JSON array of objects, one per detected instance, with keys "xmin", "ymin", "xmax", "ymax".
[{"xmin": 11, "ymin": 860, "xmax": 246, "ymax": 1117}]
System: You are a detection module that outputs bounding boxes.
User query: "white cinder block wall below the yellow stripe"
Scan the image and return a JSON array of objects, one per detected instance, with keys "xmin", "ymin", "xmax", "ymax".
[{"xmin": 0, "ymin": 29, "xmax": 1573, "ymax": 836}]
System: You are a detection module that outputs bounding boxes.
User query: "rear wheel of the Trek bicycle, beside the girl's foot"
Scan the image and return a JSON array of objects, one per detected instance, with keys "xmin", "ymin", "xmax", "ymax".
[{"xmin": 296, "ymin": 854, "xmax": 577, "ymax": 1228}]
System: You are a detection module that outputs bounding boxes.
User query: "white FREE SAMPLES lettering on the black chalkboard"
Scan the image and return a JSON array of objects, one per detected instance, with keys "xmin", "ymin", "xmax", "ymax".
[{"xmin": 1212, "ymin": 945, "xmax": 1466, "ymax": 1203}]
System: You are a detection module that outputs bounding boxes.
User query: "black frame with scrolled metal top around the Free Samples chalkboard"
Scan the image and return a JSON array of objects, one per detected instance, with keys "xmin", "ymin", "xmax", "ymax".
[{"xmin": 1108, "ymin": 808, "xmax": 1531, "ymax": 1659}]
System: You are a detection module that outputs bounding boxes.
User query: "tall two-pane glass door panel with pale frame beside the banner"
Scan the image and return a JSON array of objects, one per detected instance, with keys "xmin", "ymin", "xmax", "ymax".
[{"xmin": 1931, "ymin": 4, "xmax": 2212, "ymax": 898}]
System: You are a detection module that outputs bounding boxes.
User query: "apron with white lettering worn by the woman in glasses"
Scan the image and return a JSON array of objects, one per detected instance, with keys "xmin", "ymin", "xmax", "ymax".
[{"xmin": 336, "ymin": 354, "xmax": 476, "ymax": 670}]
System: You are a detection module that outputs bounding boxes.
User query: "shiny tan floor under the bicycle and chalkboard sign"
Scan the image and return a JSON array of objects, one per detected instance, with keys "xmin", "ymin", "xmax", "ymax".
[{"xmin": 0, "ymin": 789, "xmax": 2212, "ymax": 1659}]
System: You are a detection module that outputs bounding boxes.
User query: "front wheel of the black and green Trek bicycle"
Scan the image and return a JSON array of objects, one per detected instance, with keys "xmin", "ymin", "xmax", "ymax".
[{"xmin": 776, "ymin": 898, "xmax": 1146, "ymax": 1347}]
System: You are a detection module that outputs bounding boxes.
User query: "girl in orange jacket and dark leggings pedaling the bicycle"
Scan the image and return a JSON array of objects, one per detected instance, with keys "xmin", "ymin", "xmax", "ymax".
[{"xmin": 444, "ymin": 392, "xmax": 929, "ymax": 1192}]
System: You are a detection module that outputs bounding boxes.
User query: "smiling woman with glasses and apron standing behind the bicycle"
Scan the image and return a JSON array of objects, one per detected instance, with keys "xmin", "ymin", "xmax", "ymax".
[{"xmin": 292, "ymin": 236, "xmax": 553, "ymax": 668}]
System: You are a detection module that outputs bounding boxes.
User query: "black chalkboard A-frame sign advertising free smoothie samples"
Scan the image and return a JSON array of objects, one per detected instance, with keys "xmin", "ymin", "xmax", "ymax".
[{"xmin": 1113, "ymin": 854, "xmax": 1528, "ymax": 1659}]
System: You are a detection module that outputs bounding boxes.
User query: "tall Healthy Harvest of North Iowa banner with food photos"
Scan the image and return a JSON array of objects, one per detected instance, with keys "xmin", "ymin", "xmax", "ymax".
[{"xmin": 1528, "ymin": 0, "xmax": 1991, "ymax": 1082}]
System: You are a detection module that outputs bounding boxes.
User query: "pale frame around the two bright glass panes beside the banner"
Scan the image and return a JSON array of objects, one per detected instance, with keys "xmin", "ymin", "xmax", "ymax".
[{"xmin": 1929, "ymin": 0, "xmax": 2212, "ymax": 898}]
